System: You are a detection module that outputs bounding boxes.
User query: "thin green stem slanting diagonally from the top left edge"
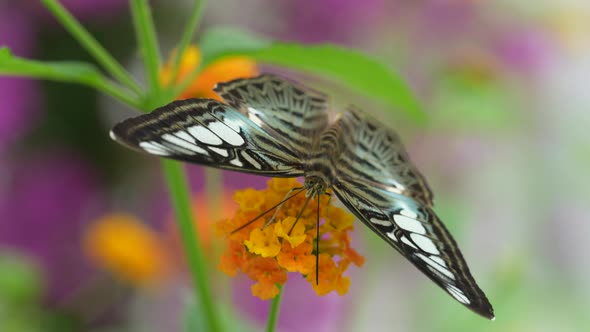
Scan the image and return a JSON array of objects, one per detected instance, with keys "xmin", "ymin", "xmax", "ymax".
[{"xmin": 41, "ymin": 0, "xmax": 141, "ymax": 94}]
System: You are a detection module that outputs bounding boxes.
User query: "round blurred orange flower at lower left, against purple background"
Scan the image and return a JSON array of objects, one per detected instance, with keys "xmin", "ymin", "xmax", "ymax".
[{"xmin": 83, "ymin": 213, "xmax": 168, "ymax": 286}]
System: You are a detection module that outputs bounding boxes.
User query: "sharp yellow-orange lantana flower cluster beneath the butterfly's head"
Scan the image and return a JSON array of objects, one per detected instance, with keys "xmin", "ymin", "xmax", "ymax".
[{"xmin": 217, "ymin": 178, "xmax": 364, "ymax": 300}]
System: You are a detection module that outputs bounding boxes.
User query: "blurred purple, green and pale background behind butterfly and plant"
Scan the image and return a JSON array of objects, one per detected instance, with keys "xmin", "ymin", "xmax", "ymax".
[{"xmin": 0, "ymin": 0, "xmax": 590, "ymax": 332}]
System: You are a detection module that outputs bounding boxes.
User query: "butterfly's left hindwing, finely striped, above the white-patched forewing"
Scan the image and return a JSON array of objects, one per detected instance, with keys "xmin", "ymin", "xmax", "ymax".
[{"xmin": 215, "ymin": 74, "xmax": 328, "ymax": 159}]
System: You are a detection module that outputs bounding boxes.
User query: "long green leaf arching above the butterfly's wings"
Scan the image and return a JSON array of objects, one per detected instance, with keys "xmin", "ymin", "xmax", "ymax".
[{"xmin": 201, "ymin": 28, "xmax": 426, "ymax": 123}]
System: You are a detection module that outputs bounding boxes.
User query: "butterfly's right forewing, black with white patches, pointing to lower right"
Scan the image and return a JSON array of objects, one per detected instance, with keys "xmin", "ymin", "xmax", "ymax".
[{"xmin": 333, "ymin": 180, "xmax": 494, "ymax": 319}]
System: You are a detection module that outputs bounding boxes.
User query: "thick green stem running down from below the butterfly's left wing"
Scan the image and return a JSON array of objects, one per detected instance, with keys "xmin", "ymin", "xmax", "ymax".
[{"xmin": 162, "ymin": 160, "xmax": 220, "ymax": 332}]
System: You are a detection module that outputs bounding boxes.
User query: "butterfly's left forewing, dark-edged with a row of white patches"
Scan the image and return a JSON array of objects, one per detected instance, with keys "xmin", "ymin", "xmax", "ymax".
[{"xmin": 111, "ymin": 99, "xmax": 303, "ymax": 177}]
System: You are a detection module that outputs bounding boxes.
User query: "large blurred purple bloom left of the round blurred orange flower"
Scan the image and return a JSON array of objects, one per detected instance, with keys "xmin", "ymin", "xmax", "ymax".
[{"xmin": 0, "ymin": 152, "xmax": 103, "ymax": 302}]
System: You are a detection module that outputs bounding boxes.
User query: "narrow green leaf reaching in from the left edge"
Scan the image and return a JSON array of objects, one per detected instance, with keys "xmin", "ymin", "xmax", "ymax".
[{"xmin": 0, "ymin": 47, "xmax": 139, "ymax": 107}]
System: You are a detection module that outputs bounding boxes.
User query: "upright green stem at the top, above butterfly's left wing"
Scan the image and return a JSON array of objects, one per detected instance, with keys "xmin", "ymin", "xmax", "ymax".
[{"xmin": 130, "ymin": 0, "xmax": 161, "ymax": 96}]
